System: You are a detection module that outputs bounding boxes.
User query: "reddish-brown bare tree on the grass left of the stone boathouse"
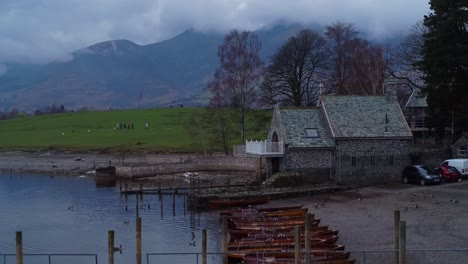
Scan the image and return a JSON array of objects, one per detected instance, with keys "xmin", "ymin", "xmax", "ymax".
[{"xmin": 209, "ymin": 30, "xmax": 263, "ymax": 141}]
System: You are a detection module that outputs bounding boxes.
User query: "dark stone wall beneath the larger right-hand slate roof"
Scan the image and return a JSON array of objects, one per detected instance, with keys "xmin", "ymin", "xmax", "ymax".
[{"xmin": 335, "ymin": 139, "xmax": 411, "ymax": 185}]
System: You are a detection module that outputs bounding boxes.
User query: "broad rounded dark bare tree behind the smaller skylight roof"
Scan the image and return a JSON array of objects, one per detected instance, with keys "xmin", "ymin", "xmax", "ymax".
[{"xmin": 261, "ymin": 29, "xmax": 326, "ymax": 106}]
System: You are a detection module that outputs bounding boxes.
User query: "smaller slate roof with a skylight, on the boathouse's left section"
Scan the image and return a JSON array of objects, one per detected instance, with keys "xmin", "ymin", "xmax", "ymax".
[{"xmin": 280, "ymin": 108, "xmax": 335, "ymax": 148}]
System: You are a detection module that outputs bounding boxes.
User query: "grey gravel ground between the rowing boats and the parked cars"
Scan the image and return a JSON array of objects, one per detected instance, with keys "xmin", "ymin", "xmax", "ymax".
[{"xmin": 271, "ymin": 181, "xmax": 468, "ymax": 264}]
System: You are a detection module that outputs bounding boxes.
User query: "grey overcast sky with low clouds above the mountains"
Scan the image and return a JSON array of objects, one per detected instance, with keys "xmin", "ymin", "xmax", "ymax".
[{"xmin": 0, "ymin": 0, "xmax": 429, "ymax": 65}]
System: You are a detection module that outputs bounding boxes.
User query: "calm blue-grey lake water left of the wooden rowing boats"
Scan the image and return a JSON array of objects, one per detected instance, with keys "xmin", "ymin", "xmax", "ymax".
[{"xmin": 0, "ymin": 173, "xmax": 221, "ymax": 264}]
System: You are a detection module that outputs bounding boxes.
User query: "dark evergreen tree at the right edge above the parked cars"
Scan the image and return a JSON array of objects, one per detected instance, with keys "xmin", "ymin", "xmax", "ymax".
[{"xmin": 418, "ymin": 0, "xmax": 468, "ymax": 134}]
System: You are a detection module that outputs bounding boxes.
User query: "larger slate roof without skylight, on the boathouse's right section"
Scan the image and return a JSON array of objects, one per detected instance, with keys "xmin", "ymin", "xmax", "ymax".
[{"xmin": 321, "ymin": 95, "xmax": 412, "ymax": 138}]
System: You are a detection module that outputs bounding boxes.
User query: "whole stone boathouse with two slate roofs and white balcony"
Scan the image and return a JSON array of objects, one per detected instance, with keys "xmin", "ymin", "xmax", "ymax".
[{"xmin": 246, "ymin": 86, "xmax": 412, "ymax": 184}]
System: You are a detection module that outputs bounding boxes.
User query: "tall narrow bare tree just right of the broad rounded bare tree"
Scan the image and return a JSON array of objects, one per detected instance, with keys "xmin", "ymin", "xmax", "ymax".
[{"xmin": 325, "ymin": 21, "xmax": 358, "ymax": 94}]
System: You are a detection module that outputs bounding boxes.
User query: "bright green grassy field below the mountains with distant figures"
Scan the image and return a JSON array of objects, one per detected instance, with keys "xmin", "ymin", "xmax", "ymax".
[{"xmin": 0, "ymin": 108, "xmax": 271, "ymax": 152}]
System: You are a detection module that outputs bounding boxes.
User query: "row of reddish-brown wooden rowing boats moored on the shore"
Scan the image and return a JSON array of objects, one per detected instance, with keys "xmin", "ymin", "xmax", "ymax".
[{"xmin": 221, "ymin": 206, "xmax": 355, "ymax": 264}]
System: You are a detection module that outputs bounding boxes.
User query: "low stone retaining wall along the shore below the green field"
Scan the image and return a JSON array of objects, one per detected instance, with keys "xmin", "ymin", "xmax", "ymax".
[{"xmin": 116, "ymin": 157, "xmax": 260, "ymax": 178}]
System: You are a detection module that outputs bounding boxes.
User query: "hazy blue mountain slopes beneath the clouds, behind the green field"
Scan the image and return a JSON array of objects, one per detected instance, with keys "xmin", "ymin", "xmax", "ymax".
[{"xmin": 0, "ymin": 25, "xmax": 302, "ymax": 111}]
